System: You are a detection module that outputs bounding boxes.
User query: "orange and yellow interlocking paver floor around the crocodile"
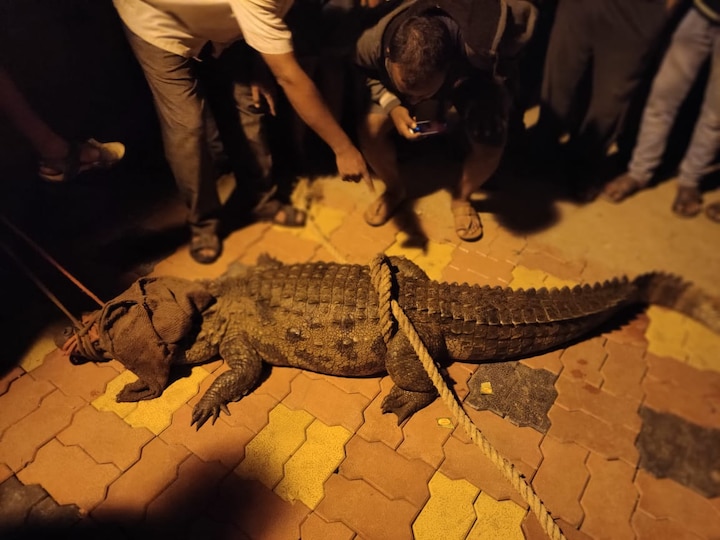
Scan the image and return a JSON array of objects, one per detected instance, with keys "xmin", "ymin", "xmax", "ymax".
[{"xmin": 0, "ymin": 154, "xmax": 720, "ymax": 540}]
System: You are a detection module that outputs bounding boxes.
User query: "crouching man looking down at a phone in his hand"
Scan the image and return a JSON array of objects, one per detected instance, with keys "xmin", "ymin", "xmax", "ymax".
[{"xmin": 355, "ymin": 0, "xmax": 536, "ymax": 241}]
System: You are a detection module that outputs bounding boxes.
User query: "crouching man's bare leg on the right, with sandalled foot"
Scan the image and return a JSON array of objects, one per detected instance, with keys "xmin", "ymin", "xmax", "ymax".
[{"xmin": 450, "ymin": 143, "xmax": 503, "ymax": 242}]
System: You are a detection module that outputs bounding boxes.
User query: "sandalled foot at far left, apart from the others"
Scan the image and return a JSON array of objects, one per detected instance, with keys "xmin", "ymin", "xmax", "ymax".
[{"xmin": 38, "ymin": 139, "xmax": 125, "ymax": 183}]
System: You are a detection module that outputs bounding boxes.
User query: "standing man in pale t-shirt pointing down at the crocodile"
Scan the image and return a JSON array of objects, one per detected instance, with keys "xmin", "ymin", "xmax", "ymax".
[{"xmin": 113, "ymin": 0, "xmax": 372, "ymax": 264}]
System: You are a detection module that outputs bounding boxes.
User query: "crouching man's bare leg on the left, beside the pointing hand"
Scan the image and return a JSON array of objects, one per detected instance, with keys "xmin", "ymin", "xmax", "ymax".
[{"xmin": 359, "ymin": 113, "xmax": 406, "ymax": 227}]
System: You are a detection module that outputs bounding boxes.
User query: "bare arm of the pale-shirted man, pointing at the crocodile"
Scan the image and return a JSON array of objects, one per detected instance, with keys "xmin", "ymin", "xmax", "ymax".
[{"xmin": 262, "ymin": 49, "xmax": 374, "ymax": 191}]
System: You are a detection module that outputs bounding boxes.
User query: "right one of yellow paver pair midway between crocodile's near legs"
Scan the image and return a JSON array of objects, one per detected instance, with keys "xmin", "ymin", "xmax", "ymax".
[{"xmin": 275, "ymin": 420, "xmax": 352, "ymax": 510}]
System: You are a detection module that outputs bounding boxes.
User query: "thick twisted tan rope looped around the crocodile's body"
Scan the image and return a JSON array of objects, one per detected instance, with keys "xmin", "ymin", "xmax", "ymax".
[{"xmin": 370, "ymin": 254, "xmax": 565, "ymax": 540}]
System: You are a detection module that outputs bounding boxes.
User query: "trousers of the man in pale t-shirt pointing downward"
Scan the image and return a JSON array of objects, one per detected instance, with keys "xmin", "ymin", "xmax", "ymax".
[{"xmin": 125, "ymin": 27, "xmax": 272, "ymax": 224}]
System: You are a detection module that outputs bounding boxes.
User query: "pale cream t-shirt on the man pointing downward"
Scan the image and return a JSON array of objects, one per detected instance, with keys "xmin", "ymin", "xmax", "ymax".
[{"xmin": 113, "ymin": 0, "xmax": 293, "ymax": 57}]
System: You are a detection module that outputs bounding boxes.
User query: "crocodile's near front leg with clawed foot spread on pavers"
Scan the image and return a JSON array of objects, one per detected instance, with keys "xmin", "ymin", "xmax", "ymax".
[{"xmin": 190, "ymin": 336, "xmax": 262, "ymax": 429}]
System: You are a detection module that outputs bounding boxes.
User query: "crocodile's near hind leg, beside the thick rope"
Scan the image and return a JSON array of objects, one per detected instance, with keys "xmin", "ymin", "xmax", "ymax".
[{"xmin": 382, "ymin": 330, "xmax": 447, "ymax": 425}]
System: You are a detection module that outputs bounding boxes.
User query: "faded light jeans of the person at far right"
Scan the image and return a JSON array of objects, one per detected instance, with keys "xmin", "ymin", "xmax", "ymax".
[{"xmin": 628, "ymin": 8, "xmax": 720, "ymax": 187}]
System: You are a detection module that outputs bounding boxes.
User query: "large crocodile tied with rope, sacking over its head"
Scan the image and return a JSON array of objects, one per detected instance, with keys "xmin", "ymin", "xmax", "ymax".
[{"xmin": 60, "ymin": 257, "xmax": 720, "ymax": 429}]
